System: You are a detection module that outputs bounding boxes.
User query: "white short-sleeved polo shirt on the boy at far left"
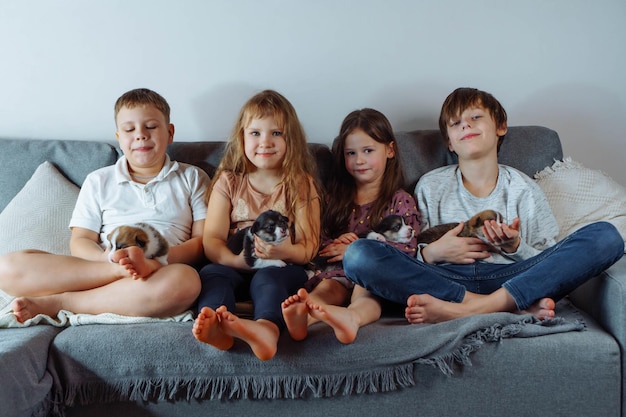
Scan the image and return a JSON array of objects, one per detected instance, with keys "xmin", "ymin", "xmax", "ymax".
[{"xmin": 70, "ymin": 155, "xmax": 209, "ymax": 245}]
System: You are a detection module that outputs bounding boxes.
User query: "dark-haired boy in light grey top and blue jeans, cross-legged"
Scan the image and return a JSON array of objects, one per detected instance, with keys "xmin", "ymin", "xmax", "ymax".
[{"xmin": 343, "ymin": 88, "xmax": 624, "ymax": 323}]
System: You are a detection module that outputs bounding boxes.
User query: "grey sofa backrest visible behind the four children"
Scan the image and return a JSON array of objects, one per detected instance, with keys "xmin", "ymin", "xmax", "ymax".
[{"xmin": 0, "ymin": 126, "xmax": 563, "ymax": 211}]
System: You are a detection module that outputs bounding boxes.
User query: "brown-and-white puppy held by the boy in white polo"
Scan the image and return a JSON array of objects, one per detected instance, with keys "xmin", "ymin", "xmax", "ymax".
[{"xmin": 107, "ymin": 223, "xmax": 169, "ymax": 265}]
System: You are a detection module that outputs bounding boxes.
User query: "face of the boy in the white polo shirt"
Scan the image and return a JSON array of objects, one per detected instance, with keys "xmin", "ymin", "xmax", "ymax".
[{"xmin": 115, "ymin": 105, "xmax": 174, "ymax": 175}]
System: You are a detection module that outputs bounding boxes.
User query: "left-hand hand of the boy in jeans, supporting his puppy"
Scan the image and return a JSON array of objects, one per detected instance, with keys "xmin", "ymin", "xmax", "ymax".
[{"xmin": 422, "ymin": 222, "xmax": 491, "ymax": 264}]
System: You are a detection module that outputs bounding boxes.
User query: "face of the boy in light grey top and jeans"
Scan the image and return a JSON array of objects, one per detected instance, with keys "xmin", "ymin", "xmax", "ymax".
[{"xmin": 447, "ymin": 107, "xmax": 507, "ymax": 159}]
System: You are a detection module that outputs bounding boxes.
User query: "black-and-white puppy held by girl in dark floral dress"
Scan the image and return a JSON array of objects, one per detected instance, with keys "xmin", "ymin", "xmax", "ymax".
[{"xmin": 306, "ymin": 214, "xmax": 415, "ymax": 278}]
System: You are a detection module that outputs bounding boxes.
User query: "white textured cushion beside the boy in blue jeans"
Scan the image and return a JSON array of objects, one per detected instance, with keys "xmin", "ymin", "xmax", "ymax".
[{"xmin": 535, "ymin": 158, "xmax": 626, "ymax": 247}]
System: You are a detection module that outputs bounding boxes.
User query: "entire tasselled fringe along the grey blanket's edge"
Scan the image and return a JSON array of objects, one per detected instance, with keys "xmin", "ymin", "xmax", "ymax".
[{"xmin": 51, "ymin": 315, "xmax": 584, "ymax": 416}]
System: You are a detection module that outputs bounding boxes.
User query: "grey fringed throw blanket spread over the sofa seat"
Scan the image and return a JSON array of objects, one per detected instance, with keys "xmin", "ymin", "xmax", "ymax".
[{"xmin": 51, "ymin": 304, "xmax": 585, "ymax": 406}]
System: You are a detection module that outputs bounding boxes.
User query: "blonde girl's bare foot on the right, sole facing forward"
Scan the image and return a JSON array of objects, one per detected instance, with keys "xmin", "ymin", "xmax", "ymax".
[{"xmin": 216, "ymin": 306, "xmax": 280, "ymax": 361}]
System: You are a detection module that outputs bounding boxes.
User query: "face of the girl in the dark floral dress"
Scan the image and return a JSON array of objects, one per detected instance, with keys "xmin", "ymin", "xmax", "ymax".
[{"xmin": 343, "ymin": 129, "xmax": 395, "ymax": 184}]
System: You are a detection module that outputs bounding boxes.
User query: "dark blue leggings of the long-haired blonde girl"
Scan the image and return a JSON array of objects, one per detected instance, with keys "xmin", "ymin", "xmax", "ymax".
[{"xmin": 198, "ymin": 264, "xmax": 307, "ymax": 330}]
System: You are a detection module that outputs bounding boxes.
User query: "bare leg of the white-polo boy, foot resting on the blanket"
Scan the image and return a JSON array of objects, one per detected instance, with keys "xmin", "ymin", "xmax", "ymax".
[{"xmin": 12, "ymin": 264, "xmax": 200, "ymax": 322}]
